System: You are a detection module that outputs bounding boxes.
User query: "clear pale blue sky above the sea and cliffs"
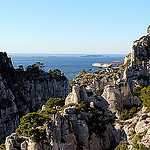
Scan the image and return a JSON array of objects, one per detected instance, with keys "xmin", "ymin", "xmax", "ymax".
[{"xmin": 0, "ymin": 0, "xmax": 150, "ymax": 54}]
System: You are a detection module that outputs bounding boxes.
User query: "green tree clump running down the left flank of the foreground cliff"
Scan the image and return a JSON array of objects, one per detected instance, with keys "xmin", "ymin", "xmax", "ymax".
[{"xmin": 16, "ymin": 98, "xmax": 64, "ymax": 143}]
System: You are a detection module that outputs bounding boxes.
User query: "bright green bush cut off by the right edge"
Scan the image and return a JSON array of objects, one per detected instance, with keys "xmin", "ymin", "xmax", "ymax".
[{"xmin": 140, "ymin": 86, "xmax": 150, "ymax": 110}]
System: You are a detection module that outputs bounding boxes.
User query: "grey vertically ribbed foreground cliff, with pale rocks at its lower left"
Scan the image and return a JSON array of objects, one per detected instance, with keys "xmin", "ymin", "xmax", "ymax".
[{"xmin": 5, "ymin": 100, "xmax": 116, "ymax": 150}]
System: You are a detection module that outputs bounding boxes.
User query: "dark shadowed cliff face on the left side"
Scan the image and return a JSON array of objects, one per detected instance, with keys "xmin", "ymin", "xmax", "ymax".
[{"xmin": 0, "ymin": 53, "xmax": 69, "ymax": 143}]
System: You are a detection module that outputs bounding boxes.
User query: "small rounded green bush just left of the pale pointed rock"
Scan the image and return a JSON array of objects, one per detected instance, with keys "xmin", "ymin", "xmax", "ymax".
[{"xmin": 45, "ymin": 98, "xmax": 65, "ymax": 108}]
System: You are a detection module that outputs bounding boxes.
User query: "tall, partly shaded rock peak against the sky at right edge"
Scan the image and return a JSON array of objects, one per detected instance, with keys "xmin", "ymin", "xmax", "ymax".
[{"xmin": 124, "ymin": 28, "xmax": 150, "ymax": 90}]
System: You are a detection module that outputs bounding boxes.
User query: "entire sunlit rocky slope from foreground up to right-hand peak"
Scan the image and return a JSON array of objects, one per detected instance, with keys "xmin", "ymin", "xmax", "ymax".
[{"xmin": 2, "ymin": 27, "xmax": 150, "ymax": 150}]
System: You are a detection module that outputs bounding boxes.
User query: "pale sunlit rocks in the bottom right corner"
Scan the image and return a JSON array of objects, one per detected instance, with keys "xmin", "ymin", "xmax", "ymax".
[{"xmin": 114, "ymin": 107, "xmax": 150, "ymax": 149}]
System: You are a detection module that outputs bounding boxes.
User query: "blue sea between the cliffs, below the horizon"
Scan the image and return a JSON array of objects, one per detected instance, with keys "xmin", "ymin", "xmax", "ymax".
[{"xmin": 8, "ymin": 54, "xmax": 127, "ymax": 82}]
